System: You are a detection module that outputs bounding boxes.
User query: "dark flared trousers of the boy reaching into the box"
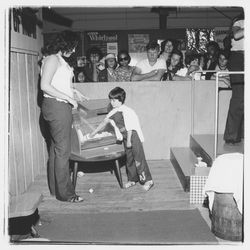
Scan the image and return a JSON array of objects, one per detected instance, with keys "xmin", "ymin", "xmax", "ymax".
[{"xmin": 124, "ymin": 130, "xmax": 152, "ymax": 182}]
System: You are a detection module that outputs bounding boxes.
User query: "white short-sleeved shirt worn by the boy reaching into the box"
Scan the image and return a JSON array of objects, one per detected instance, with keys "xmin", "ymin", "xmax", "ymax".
[{"xmin": 106, "ymin": 104, "xmax": 144, "ymax": 142}]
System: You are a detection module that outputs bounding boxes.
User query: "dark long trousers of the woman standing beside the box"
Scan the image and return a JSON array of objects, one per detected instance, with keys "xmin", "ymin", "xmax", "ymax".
[{"xmin": 42, "ymin": 98, "xmax": 75, "ymax": 201}]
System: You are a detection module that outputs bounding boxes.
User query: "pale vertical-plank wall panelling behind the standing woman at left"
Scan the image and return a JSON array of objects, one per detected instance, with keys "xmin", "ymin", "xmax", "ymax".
[{"xmin": 9, "ymin": 52, "xmax": 48, "ymax": 195}]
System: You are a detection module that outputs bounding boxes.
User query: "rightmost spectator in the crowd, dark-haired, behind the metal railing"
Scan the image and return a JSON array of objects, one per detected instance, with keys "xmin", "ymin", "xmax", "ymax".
[{"xmin": 211, "ymin": 50, "xmax": 230, "ymax": 87}]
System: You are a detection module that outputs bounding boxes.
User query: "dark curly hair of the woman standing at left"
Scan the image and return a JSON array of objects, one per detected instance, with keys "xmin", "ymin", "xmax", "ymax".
[{"xmin": 41, "ymin": 30, "xmax": 79, "ymax": 56}]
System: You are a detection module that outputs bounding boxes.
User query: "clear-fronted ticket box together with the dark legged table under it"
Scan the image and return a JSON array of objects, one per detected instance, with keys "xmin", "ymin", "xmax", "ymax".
[{"xmin": 70, "ymin": 99, "xmax": 125, "ymax": 188}]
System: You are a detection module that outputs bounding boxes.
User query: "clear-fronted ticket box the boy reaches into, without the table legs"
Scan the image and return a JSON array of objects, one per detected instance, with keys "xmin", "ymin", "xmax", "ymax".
[{"xmin": 71, "ymin": 99, "xmax": 124, "ymax": 159}]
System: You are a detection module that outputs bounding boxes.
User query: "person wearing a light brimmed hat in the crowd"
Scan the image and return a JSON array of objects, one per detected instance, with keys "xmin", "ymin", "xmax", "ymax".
[{"xmin": 98, "ymin": 53, "xmax": 117, "ymax": 82}]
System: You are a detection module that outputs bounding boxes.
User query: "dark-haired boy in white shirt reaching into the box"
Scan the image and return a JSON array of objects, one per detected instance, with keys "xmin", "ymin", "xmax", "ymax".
[{"xmin": 90, "ymin": 87, "xmax": 154, "ymax": 191}]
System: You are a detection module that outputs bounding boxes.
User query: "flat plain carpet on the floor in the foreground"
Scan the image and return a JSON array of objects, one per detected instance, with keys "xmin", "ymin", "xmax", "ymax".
[{"xmin": 36, "ymin": 209, "xmax": 218, "ymax": 245}]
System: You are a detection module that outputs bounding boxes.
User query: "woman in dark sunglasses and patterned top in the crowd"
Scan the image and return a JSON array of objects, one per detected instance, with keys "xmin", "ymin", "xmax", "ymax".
[{"xmin": 116, "ymin": 50, "xmax": 134, "ymax": 82}]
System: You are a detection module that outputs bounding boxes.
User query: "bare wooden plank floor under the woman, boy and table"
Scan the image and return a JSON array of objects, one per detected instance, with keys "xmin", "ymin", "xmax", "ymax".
[{"xmin": 26, "ymin": 160, "xmax": 193, "ymax": 214}]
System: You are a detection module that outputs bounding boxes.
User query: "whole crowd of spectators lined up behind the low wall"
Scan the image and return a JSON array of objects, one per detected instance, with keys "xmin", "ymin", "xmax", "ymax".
[{"xmin": 75, "ymin": 37, "xmax": 231, "ymax": 86}]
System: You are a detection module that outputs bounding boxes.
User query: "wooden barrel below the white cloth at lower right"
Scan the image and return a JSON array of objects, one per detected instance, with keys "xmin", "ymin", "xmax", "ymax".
[{"xmin": 211, "ymin": 193, "xmax": 243, "ymax": 241}]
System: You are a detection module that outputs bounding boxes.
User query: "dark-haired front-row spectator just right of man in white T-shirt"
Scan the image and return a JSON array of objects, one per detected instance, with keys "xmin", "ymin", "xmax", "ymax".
[{"xmin": 161, "ymin": 50, "xmax": 191, "ymax": 81}]
